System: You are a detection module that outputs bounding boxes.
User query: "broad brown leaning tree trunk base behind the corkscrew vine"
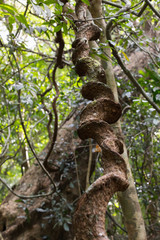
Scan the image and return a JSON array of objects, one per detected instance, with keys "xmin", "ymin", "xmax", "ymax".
[{"xmin": 0, "ymin": 112, "xmax": 97, "ymax": 240}]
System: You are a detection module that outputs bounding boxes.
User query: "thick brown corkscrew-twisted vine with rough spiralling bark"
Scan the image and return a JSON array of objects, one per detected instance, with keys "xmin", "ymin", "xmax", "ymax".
[{"xmin": 72, "ymin": 0, "xmax": 128, "ymax": 240}]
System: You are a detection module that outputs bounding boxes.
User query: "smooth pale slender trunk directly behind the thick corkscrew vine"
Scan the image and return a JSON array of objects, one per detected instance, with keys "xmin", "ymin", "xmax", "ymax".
[{"xmin": 90, "ymin": 0, "xmax": 147, "ymax": 240}]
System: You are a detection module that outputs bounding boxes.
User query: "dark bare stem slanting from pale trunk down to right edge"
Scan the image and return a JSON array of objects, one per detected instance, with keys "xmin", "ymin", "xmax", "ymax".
[{"xmin": 106, "ymin": 19, "xmax": 160, "ymax": 113}]
